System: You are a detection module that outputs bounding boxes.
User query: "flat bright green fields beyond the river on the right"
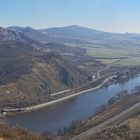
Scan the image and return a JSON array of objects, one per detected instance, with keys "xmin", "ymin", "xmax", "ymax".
[{"xmin": 87, "ymin": 48, "xmax": 140, "ymax": 66}]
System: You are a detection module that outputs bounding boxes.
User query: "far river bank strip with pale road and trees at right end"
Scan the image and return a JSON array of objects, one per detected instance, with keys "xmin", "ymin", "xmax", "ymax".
[{"xmin": 2, "ymin": 68, "xmax": 137, "ymax": 116}]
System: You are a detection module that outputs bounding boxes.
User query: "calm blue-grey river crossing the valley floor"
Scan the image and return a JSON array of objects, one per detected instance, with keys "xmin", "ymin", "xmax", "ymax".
[{"xmin": 7, "ymin": 76, "xmax": 140, "ymax": 134}]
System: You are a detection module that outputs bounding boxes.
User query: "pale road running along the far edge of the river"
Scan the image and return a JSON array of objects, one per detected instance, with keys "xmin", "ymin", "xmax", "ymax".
[{"xmin": 3, "ymin": 75, "xmax": 114, "ymax": 112}]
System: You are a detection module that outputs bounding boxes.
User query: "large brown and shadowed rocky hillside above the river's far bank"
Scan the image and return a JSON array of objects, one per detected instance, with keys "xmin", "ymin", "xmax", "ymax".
[{"xmin": 0, "ymin": 29, "xmax": 90, "ymax": 107}]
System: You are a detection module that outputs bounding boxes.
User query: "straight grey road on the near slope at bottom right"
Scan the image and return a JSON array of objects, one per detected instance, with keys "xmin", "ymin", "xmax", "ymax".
[{"xmin": 70, "ymin": 102, "xmax": 140, "ymax": 140}]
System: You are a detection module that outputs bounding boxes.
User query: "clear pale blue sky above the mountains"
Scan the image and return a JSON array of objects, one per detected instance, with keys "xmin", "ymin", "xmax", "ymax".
[{"xmin": 0, "ymin": 0, "xmax": 140, "ymax": 33}]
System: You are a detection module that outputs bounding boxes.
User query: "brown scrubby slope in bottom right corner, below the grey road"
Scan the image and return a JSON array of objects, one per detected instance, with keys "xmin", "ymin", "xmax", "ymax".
[{"xmin": 82, "ymin": 116, "xmax": 140, "ymax": 140}]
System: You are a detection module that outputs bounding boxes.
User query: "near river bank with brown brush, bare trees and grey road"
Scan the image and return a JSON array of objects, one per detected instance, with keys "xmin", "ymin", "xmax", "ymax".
[{"xmin": 59, "ymin": 89, "xmax": 140, "ymax": 140}]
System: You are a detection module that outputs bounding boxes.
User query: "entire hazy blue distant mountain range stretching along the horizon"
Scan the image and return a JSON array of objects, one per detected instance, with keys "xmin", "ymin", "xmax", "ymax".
[{"xmin": 8, "ymin": 25, "xmax": 140, "ymax": 47}]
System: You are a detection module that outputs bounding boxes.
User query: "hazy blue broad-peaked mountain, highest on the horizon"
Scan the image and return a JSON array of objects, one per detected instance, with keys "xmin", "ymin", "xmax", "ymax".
[{"xmin": 39, "ymin": 25, "xmax": 112, "ymax": 41}]
